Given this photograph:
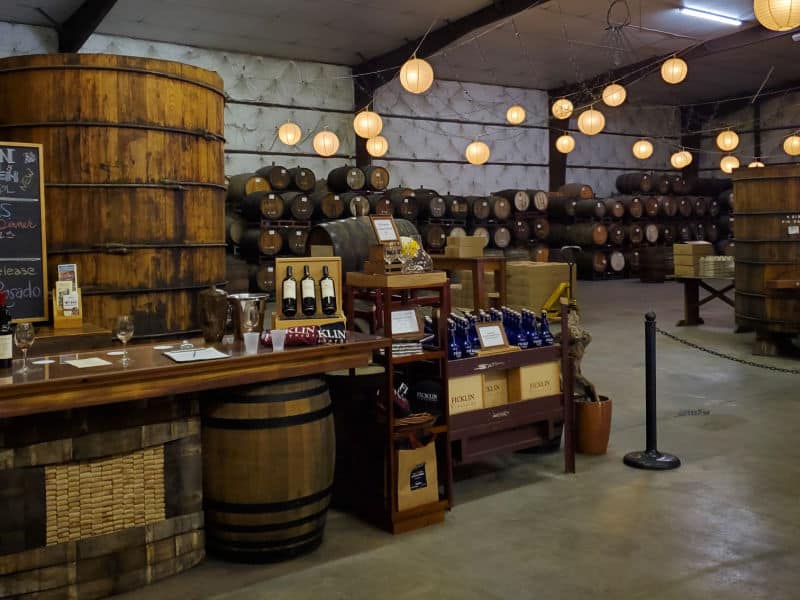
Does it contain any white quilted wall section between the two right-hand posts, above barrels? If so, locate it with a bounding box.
[565,103,681,197]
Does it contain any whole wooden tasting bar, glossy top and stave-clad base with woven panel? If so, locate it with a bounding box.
[0,333,389,600]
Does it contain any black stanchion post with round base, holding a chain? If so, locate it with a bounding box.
[623,311,681,471]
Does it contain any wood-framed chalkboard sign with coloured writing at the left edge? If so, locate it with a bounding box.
[0,142,48,322]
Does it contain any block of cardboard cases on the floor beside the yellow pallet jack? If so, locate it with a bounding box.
[506,261,577,312]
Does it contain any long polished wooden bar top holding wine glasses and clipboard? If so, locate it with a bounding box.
[0,332,390,418]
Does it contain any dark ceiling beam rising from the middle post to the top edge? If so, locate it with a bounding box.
[353,0,547,96]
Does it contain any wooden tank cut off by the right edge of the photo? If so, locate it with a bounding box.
[733,165,800,337]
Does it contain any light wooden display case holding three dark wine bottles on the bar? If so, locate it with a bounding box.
[272,256,345,329]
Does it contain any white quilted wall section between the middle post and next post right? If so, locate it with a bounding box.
[373,79,549,195]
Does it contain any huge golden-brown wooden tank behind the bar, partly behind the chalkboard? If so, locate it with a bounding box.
[0,54,225,336]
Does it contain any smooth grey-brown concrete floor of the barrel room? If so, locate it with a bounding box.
[120,281,800,600]
